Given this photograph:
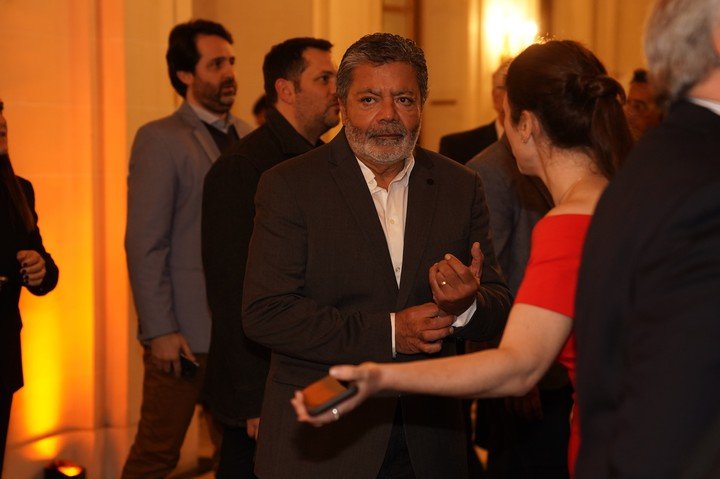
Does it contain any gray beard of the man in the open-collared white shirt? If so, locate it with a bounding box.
[345,120,420,165]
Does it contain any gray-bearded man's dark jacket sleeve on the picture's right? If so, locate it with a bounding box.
[455,174,512,341]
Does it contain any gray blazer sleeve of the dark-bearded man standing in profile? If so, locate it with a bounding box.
[125,126,179,340]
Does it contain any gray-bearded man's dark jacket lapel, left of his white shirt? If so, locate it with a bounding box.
[328,130,397,291]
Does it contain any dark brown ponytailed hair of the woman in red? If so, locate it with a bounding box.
[506,40,633,178]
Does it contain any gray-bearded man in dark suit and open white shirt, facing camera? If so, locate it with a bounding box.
[243,34,510,479]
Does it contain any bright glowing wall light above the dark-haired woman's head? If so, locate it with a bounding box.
[484,0,538,62]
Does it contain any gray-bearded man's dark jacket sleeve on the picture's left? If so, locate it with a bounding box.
[243,170,392,365]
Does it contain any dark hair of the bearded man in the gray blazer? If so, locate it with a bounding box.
[165,20,232,98]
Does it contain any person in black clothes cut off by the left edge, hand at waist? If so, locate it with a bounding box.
[0,98,58,476]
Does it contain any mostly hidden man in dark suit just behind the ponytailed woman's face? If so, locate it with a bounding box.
[438,60,510,164]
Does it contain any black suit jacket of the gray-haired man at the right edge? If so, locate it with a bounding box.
[575,101,720,479]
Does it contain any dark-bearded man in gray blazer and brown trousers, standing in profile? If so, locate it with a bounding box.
[122,20,250,479]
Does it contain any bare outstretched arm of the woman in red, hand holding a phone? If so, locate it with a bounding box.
[292,304,572,426]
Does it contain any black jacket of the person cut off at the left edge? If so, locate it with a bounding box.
[0,178,58,394]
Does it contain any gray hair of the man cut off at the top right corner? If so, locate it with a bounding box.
[645,0,720,101]
